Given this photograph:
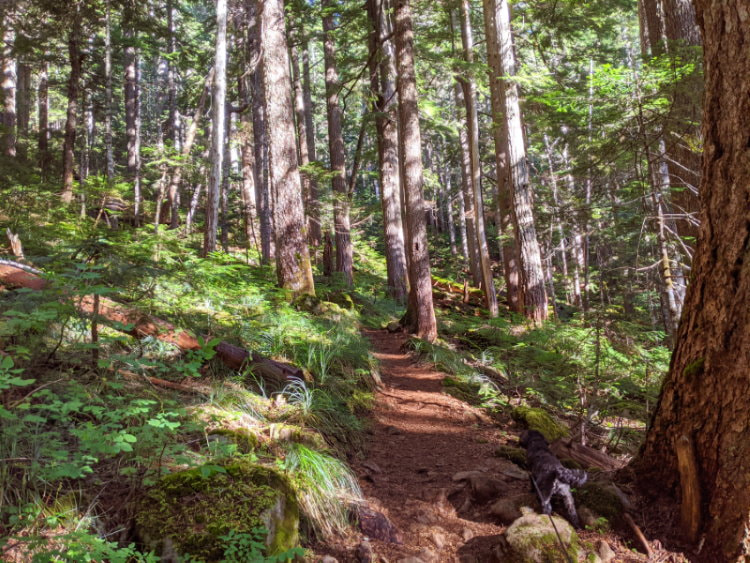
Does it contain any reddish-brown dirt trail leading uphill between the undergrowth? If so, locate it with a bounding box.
[315,331,656,563]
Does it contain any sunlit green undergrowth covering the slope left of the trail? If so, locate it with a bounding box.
[0,222,398,561]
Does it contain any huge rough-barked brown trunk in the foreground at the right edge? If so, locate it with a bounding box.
[636,4,750,561]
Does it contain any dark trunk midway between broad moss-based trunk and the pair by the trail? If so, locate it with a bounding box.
[322,0,354,286]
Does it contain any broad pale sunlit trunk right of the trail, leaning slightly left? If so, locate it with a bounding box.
[495,0,548,322]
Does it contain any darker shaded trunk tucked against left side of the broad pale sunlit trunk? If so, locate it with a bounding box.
[483,0,523,313]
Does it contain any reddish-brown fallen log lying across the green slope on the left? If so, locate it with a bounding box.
[0,261,305,386]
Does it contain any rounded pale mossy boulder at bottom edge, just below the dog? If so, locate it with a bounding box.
[505,511,582,563]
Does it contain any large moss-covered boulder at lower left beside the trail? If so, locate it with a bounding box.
[135,459,299,561]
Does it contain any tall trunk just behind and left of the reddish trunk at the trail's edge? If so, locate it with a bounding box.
[367,0,408,303]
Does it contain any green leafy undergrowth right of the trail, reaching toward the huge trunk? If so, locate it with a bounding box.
[410,304,670,457]
